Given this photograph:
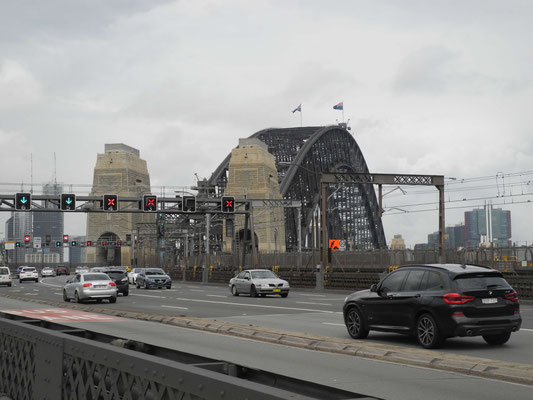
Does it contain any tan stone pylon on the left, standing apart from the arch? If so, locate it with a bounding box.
[86,143,157,266]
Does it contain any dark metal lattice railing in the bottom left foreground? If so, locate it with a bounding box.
[0,318,375,400]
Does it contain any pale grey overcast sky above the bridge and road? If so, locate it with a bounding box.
[0,0,533,246]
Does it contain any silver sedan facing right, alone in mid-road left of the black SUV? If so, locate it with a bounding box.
[229,269,290,297]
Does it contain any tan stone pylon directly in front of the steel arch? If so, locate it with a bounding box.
[224,139,285,252]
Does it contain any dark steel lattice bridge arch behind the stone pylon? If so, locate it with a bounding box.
[208,125,386,251]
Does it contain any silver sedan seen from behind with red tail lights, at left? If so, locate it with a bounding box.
[63,272,117,303]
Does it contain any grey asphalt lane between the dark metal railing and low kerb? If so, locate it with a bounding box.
[1,296,532,400]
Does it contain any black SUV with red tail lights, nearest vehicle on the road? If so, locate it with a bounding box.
[343,264,522,349]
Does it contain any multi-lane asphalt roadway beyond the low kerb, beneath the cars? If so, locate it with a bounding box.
[4,276,533,364]
